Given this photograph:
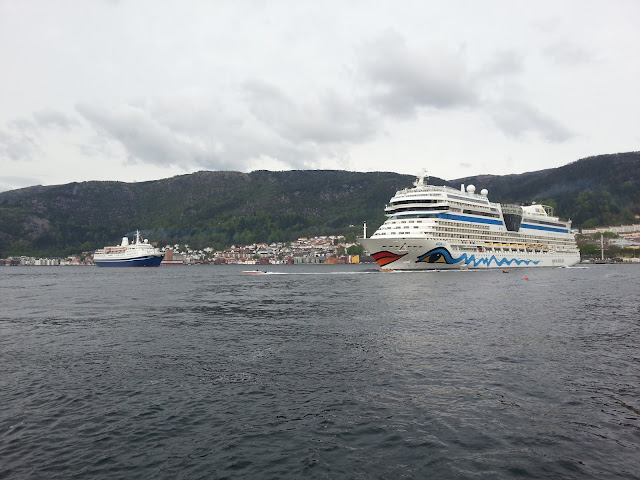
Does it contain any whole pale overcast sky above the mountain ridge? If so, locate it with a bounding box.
[0,0,640,191]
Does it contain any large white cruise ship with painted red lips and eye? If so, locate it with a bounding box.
[358,173,580,270]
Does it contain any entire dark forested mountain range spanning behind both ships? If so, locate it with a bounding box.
[0,152,640,258]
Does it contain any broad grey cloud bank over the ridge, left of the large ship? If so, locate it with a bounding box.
[76,80,377,171]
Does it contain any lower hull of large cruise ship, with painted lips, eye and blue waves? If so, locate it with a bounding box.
[358,238,580,270]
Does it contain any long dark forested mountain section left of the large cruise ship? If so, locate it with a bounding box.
[0,170,432,258]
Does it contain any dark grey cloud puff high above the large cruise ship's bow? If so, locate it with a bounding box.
[359,32,476,117]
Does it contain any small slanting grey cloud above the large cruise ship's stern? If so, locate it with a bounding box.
[489,100,574,143]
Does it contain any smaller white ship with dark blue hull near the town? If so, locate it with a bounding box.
[93,230,164,267]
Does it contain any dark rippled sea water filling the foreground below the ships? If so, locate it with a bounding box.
[0,265,640,479]
